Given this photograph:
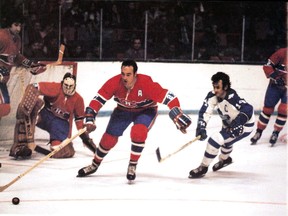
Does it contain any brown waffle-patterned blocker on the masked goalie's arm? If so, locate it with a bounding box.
[17,84,39,116]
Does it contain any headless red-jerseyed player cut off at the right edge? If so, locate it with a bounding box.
[251,48,288,146]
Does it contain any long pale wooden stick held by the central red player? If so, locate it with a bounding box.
[0,128,86,192]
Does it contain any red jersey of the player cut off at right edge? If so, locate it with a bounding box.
[263,48,288,84]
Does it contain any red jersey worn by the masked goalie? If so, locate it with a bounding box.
[38,82,85,135]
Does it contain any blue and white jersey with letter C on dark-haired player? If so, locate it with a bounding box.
[198,89,255,127]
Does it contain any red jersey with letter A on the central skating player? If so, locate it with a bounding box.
[89,74,180,112]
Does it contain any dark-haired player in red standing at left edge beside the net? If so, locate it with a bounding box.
[0,13,46,119]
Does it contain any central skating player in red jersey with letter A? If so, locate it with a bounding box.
[77,60,191,181]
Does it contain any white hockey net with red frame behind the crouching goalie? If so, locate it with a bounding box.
[0,62,77,149]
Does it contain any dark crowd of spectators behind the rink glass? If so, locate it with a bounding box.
[0,0,287,63]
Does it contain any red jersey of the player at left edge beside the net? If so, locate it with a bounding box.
[0,28,24,68]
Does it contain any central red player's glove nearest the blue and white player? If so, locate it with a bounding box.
[169,107,192,134]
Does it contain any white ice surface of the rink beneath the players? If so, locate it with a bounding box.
[0,115,287,216]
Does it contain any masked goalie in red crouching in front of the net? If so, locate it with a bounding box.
[9,72,96,159]
